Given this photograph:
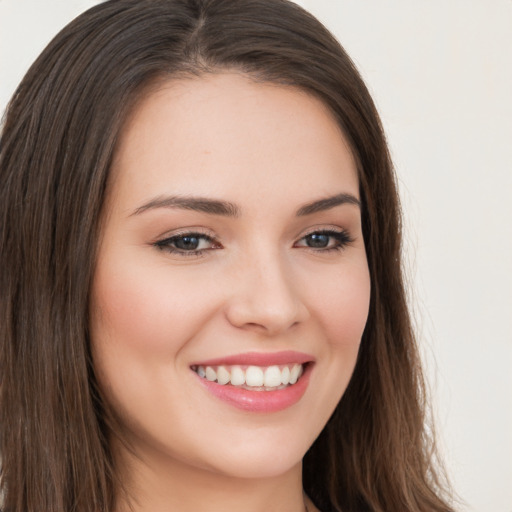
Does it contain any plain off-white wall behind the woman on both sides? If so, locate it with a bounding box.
[0,0,512,512]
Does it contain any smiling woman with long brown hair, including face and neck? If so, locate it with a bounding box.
[0,0,451,512]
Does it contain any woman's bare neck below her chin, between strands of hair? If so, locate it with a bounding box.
[116,440,306,512]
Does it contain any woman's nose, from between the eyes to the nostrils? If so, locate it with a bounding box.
[226,251,309,336]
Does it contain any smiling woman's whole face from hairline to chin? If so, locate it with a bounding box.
[91,73,370,477]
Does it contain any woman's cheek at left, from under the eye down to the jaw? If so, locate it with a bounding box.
[91,253,215,435]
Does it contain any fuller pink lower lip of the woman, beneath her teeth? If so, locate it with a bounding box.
[197,363,313,412]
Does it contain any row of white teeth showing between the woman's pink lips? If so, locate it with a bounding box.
[193,364,303,389]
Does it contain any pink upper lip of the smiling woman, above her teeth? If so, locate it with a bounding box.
[191,350,315,366]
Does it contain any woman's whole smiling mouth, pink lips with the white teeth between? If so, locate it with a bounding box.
[191,351,314,412]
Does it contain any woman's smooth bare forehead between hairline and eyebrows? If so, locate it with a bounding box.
[113,73,358,213]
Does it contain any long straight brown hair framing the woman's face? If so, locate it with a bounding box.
[0,0,451,512]
